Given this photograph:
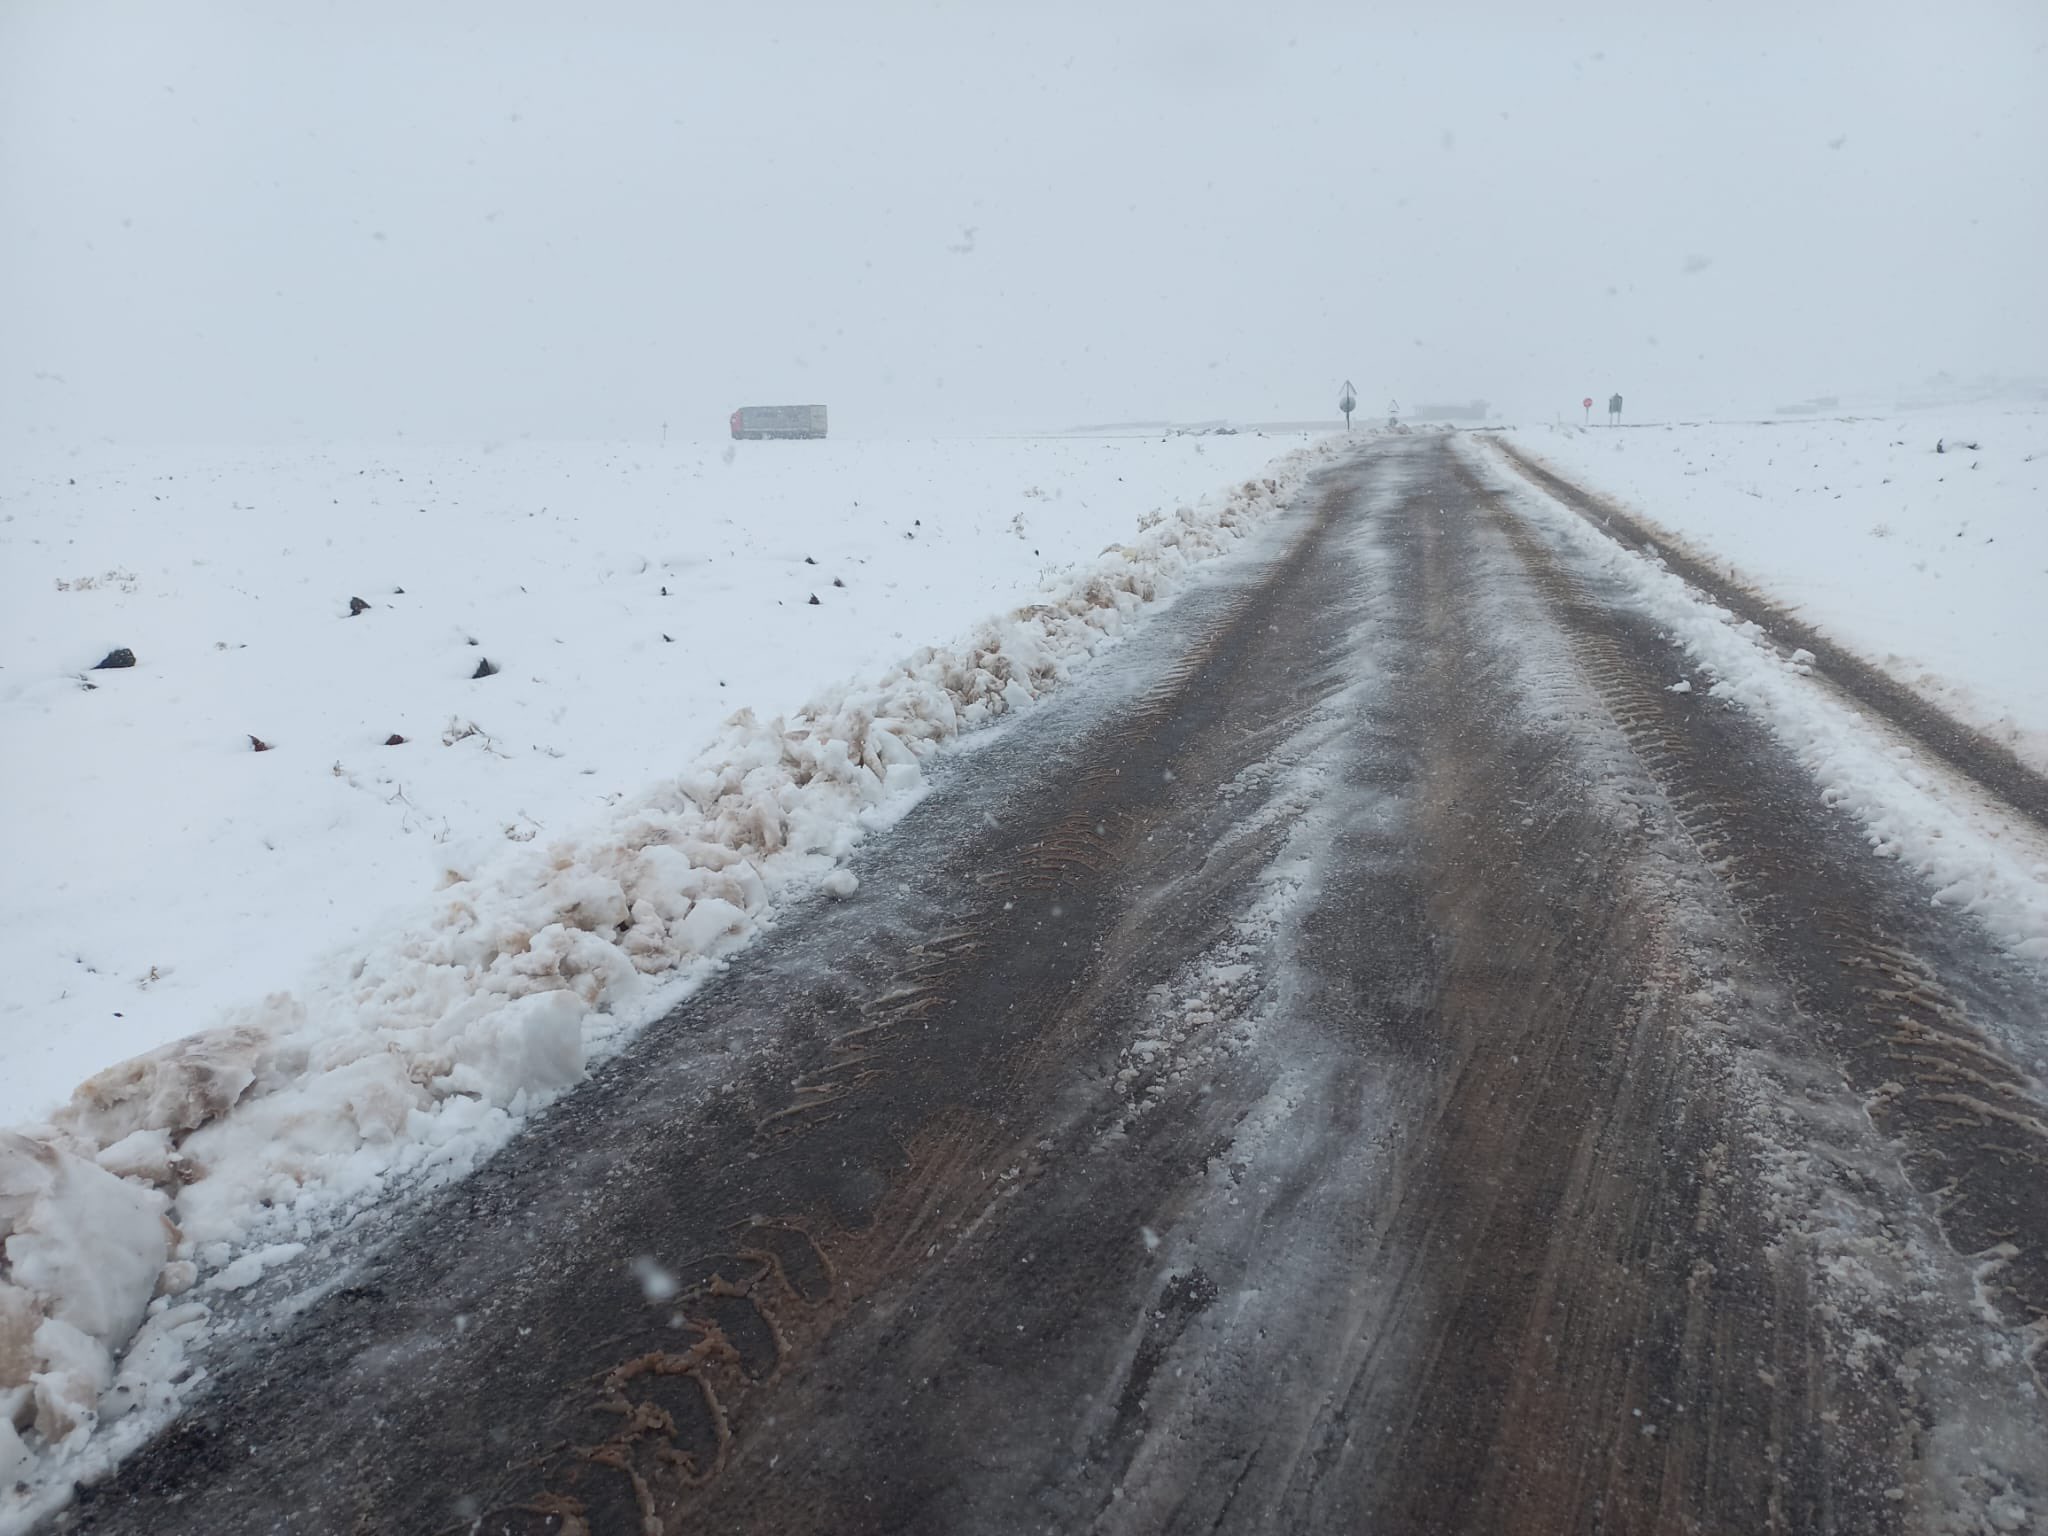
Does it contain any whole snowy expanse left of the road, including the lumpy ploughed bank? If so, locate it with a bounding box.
[0,436,1337,1530]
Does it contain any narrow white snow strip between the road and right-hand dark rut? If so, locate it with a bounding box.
[1468,428,2048,963]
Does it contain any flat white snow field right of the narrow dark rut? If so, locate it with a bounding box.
[1509,406,2048,770]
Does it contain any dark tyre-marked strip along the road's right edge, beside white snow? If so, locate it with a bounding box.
[1503,462,2048,1329]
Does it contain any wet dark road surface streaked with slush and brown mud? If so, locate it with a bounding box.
[59,436,2048,1536]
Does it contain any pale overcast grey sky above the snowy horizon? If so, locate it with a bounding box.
[0,0,2048,440]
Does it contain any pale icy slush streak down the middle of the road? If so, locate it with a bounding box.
[1075,483,1407,1526]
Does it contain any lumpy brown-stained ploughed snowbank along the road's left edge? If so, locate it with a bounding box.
[0,428,1341,1489]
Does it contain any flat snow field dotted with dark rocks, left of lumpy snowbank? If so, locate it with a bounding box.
[0,434,1305,1124]
